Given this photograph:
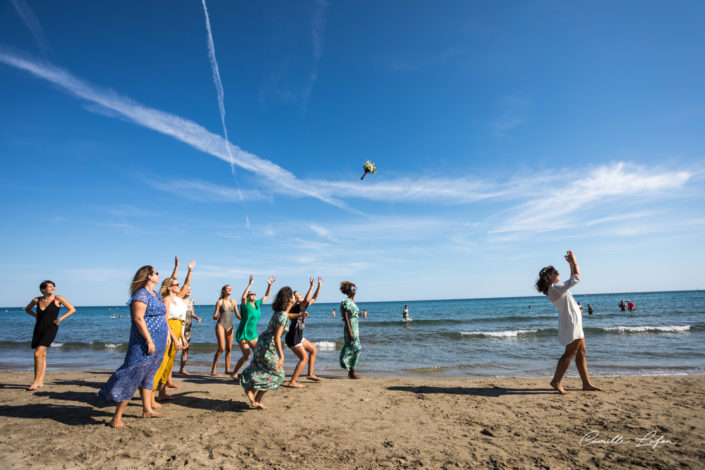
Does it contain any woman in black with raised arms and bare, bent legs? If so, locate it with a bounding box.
[285,277,323,388]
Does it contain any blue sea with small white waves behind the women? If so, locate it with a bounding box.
[0,291,705,377]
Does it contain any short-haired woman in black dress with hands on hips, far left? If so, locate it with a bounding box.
[24,281,76,391]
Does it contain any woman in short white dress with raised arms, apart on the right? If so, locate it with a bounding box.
[536,250,602,395]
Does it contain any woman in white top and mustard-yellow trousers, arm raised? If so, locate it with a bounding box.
[152,258,196,402]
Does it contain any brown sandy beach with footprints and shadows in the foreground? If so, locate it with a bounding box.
[0,371,705,468]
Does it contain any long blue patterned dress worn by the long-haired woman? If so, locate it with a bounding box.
[98,288,167,403]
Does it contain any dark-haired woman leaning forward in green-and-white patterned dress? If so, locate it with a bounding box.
[240,286,296,410]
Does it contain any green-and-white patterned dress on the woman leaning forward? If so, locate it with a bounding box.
[240,312,289,390]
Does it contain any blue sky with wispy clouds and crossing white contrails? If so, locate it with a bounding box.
[0,0,705,305]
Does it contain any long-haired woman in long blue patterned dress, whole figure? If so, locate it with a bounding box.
[98,266,169,429]
